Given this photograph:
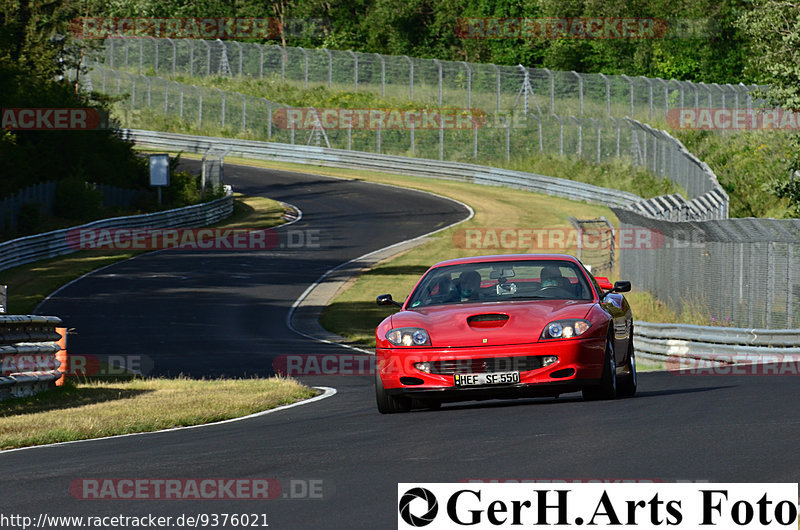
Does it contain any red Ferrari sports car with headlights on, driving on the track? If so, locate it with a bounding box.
[375,254,636,414]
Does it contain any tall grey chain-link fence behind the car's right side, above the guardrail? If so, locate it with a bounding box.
[613,208,800,328]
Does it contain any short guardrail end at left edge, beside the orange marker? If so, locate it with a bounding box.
[0,315,62,400]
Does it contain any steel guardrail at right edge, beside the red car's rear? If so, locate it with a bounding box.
[634,322,800,365]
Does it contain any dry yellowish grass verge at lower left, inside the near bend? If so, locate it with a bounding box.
[0,378,317,449]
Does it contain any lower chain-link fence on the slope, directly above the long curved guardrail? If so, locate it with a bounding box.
[82,66,727,219]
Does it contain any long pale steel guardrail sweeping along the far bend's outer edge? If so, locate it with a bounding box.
[120,129,642,207]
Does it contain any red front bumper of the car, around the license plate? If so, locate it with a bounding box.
[376,337,606,401]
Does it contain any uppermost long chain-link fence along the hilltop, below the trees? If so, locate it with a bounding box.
[97,37,763,122]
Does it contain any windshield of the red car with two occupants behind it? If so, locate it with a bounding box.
[408,260,592,308]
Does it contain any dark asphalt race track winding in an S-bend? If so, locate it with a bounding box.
[0,165,800,529]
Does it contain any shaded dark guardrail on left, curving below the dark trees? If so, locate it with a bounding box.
[0,188,233,270]
